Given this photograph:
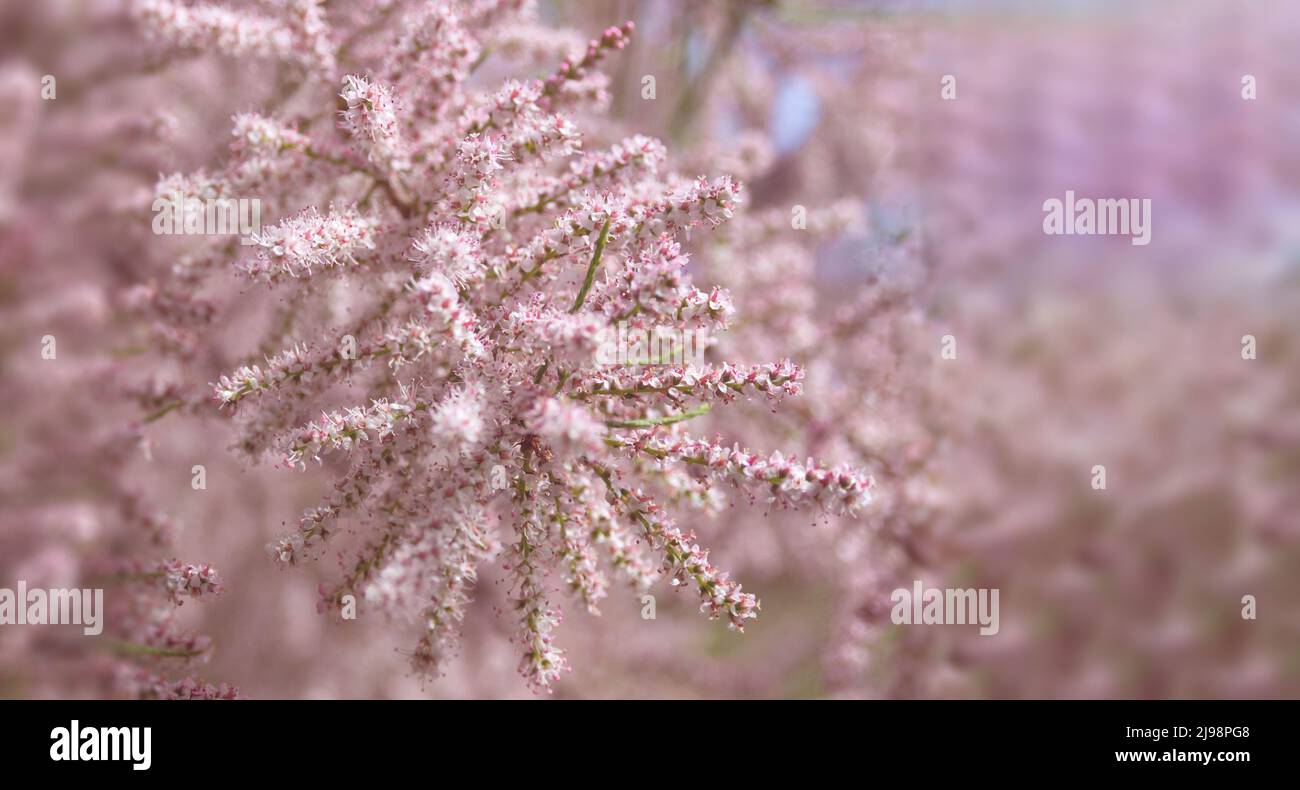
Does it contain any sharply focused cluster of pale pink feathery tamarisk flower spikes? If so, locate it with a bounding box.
[126,0,872,691]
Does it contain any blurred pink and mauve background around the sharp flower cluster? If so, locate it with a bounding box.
[0,0,1300,698]
